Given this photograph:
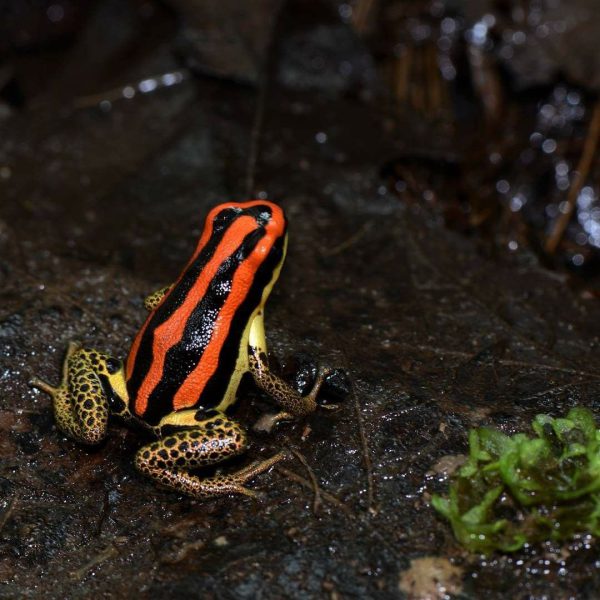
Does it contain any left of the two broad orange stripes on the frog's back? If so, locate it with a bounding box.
[135,216,256,415]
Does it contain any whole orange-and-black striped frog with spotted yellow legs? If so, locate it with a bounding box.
[32,200,330,498]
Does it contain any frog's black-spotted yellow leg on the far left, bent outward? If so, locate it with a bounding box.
[31,343,115,444]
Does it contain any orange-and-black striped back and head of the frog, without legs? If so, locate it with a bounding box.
[126,200,286,425]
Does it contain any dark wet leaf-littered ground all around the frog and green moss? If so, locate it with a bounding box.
[0,0,600,599]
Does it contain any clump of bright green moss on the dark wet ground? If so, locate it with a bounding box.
[431,408,600,553]
